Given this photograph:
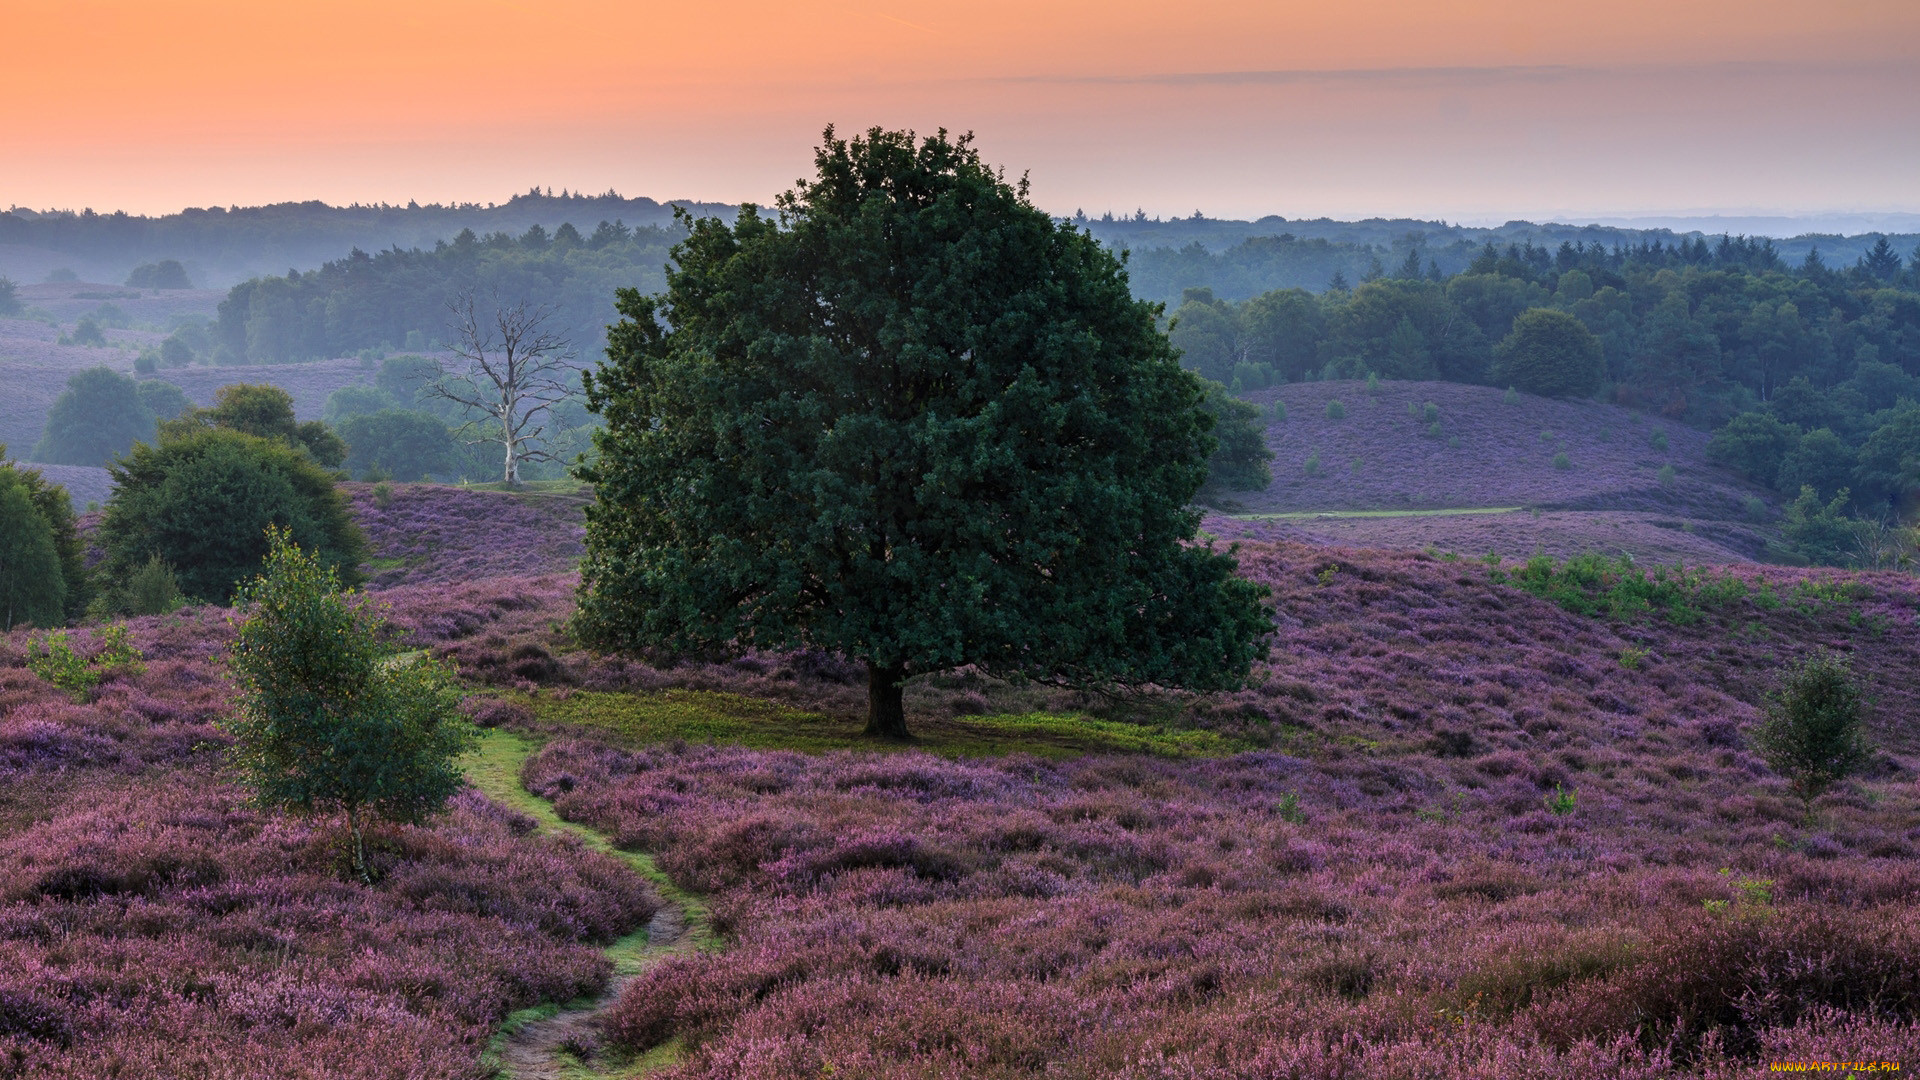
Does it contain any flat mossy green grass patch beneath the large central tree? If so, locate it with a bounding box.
[534,690,1248,757]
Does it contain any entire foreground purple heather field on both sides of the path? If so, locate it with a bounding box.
[0,426,1920,1080]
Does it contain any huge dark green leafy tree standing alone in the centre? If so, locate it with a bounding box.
[578,129,1269,736]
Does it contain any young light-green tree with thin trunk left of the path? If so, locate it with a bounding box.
[221,528,474,882]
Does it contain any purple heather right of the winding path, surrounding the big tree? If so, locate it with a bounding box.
[360,544,1920,1080]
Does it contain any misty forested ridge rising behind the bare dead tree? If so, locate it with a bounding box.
[213,221,684,363]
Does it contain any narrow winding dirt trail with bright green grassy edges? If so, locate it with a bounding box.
[467,728,714,1080]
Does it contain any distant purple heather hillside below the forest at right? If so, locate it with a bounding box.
[1210,380,1778,563]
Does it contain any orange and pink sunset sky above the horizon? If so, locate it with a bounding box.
[11,0,1920,221]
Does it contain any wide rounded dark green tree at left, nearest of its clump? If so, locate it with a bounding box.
[100,429,365,603]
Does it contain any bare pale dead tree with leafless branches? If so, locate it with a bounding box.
[424,292,580,484]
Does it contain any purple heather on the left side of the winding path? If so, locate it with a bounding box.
[0,595,659,1080]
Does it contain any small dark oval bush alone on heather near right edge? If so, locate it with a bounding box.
[1753,651,1868,809]
